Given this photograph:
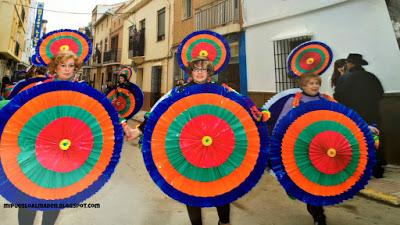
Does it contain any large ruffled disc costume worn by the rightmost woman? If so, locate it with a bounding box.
[270,100,375,206]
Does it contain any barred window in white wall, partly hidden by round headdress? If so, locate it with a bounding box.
[274,36,311,92]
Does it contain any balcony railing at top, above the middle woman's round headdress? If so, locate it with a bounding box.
[195,0,240,30]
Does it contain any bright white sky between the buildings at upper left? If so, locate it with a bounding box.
[38,0,124,32]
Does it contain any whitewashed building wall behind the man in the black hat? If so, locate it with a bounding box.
[244,0,400,93]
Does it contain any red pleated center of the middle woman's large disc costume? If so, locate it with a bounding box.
[179,115,235,168]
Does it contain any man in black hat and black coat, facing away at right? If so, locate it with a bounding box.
[333,53,384,178]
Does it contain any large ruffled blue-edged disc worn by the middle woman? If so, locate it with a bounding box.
[142,84,268,207]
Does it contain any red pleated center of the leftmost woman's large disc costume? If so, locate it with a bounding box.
[35,117,93,173]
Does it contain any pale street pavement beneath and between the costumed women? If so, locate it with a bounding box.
[0,118,400,225]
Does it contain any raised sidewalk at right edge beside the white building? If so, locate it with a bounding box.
[360,165,400,206]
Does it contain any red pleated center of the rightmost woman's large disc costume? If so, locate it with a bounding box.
[309,131,352,174]
